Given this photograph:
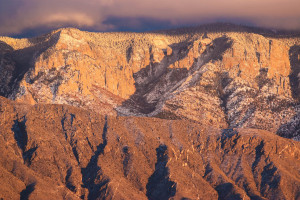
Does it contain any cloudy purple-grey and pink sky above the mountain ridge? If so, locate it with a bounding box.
[0,0,300,36]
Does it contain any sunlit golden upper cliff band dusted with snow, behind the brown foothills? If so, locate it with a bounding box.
[0,29,300,139]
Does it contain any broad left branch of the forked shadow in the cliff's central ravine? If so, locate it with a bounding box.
[118,38,192,114]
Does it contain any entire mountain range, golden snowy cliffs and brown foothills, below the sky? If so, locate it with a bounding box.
[0,24,300,200]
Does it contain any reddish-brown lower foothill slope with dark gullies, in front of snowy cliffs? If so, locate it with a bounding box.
[0,98,300,200]
